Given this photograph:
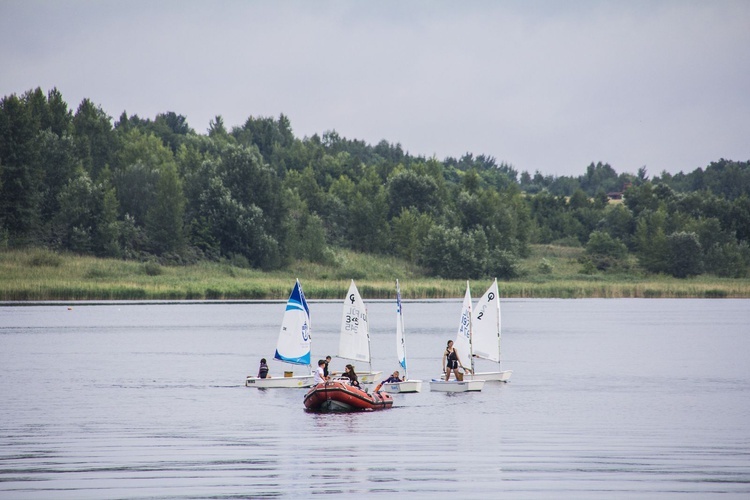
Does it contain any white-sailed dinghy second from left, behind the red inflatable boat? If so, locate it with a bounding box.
[338,280,383,384]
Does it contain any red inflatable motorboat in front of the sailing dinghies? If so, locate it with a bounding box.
[305,378,393,412]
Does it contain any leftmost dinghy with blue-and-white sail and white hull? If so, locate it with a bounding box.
[245,280,313,389]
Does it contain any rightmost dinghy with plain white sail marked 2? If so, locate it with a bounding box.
[471,278,513,382]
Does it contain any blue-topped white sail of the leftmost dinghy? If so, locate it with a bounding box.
[274,280,311,365]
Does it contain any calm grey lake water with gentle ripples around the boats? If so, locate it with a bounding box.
[0,299,750,500]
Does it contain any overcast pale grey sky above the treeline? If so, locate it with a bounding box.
[0,0,750,175]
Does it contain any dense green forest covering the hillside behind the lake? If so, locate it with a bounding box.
[0,88,750,279]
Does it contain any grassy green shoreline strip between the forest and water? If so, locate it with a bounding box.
[0,245,750,302]
